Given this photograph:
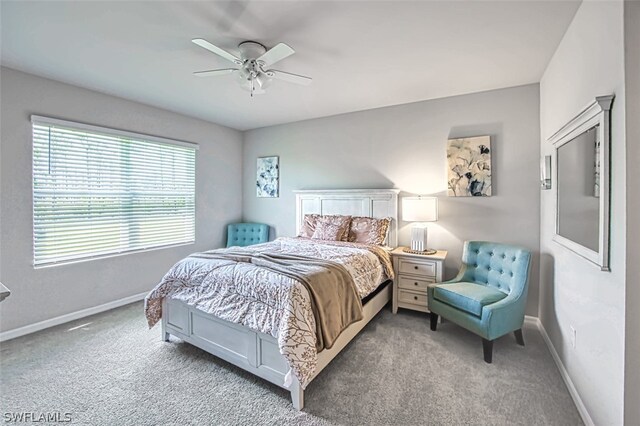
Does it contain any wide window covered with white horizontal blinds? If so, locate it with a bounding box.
[31,116,197,266]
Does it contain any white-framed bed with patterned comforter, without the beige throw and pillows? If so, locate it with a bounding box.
[145,190,398,410]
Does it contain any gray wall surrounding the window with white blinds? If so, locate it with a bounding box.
[0,68,242,331]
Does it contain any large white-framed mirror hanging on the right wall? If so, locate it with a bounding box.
[549,96,613,271]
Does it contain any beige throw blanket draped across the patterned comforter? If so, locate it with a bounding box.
[191,249,362,352]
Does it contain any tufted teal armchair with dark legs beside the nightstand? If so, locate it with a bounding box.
[427,241,531,363]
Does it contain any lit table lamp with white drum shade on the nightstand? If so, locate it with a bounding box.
[402,197,438,255]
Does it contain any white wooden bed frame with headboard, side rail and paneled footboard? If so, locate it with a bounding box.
[162,189,398,410]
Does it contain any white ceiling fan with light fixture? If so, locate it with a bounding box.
[191,38,312,97]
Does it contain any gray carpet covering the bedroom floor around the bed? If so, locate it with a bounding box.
[0,303,582,425]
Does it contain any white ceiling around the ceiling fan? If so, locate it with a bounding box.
[1,0,579,130]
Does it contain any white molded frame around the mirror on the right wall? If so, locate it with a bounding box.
[548,95,613,271]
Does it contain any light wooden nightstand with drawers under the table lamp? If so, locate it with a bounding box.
[391,247,447,314]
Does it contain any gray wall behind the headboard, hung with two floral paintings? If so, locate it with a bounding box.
[243,84,540,316]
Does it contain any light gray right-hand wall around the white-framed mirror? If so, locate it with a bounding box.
[539,0,624,425]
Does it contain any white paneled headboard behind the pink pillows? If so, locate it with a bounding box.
[293,189,400,247]
